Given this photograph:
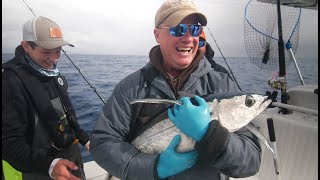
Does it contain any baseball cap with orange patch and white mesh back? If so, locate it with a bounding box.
[23,16,74,49]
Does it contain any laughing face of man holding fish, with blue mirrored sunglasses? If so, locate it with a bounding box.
[154,14,202,77]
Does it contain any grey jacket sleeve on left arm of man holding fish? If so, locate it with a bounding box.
[90,82,157,180]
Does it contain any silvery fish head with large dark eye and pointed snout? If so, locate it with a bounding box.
[209,94,272,132]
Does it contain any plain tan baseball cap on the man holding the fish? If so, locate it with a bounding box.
[155,0,207,27]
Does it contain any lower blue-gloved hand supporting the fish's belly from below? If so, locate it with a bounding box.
[157,135,199,179]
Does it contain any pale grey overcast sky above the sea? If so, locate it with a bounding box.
[2,0,318,58]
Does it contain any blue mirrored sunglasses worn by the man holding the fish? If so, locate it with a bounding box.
[159,24,203,37]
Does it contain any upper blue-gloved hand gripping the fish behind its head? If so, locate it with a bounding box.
[168,96,210,141]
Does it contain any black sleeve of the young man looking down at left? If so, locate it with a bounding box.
[2,70,54,174]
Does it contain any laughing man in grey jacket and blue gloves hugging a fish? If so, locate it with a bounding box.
[90,0,261,180]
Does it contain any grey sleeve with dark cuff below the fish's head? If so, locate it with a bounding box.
[195,121,261,178]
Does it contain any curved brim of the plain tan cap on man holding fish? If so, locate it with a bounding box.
[164,10,207,26]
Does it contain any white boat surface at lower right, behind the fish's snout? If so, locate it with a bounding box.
[231,85,318,180]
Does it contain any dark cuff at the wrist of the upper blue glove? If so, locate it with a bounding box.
[195,120,229,162]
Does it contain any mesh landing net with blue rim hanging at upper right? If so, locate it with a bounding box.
[244,0,301,70]
